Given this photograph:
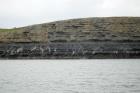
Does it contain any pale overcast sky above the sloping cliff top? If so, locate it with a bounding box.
[0,0,140,28]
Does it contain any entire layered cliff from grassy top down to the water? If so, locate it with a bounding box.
[0,17,140,59]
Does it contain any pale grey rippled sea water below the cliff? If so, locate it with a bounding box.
[0,60,140,93]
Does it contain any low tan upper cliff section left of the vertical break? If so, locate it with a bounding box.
[0,26,48,43]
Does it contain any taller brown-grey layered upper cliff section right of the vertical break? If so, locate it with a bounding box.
[44,18,140,42]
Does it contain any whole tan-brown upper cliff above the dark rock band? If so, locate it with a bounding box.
[0,17,140,42]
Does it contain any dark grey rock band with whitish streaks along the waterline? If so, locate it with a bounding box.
[0,41,140,59]
